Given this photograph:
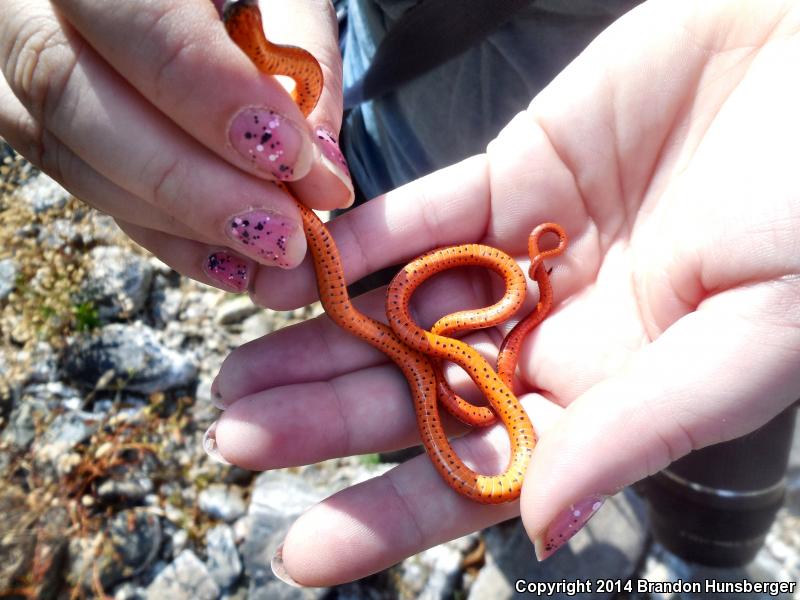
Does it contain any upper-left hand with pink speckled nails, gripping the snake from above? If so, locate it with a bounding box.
[0,0,353,292]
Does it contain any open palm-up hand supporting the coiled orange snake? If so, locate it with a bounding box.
[211,0,800,585]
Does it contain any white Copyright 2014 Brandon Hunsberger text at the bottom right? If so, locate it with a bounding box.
[514,579,798,597]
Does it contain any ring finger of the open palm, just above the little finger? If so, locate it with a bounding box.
[215,365,438,471]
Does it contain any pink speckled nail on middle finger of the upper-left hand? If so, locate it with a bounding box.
[228,210,304,268]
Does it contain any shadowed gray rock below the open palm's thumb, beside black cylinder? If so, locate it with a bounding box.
[468,490,647,600]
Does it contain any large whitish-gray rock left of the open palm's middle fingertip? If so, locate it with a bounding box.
[64,323,197,394]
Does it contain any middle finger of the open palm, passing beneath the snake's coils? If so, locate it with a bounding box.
[214,260,502,406]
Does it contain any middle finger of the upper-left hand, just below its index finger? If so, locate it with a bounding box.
[0,0,305,267]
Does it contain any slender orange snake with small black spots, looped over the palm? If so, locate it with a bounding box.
[224,0,567,504]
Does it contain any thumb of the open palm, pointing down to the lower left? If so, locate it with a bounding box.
[520,281,800,560]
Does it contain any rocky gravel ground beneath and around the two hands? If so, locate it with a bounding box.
[0,144,800,600]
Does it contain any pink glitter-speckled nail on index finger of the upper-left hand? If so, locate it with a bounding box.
[228,107,314,181]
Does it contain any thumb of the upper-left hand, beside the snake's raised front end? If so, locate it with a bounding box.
[259,0,353,210]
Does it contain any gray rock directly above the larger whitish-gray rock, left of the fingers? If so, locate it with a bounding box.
[87,246,153,321]
